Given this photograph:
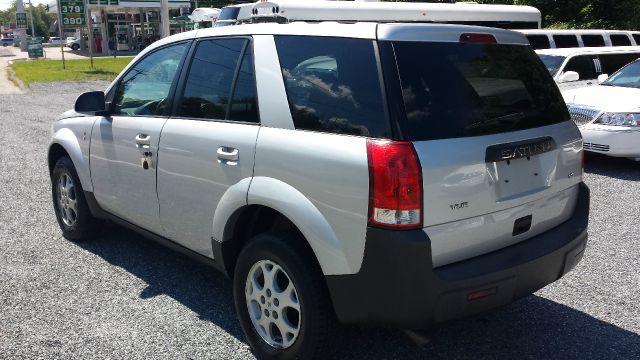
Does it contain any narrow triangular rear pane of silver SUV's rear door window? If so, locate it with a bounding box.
[228,46,260,123]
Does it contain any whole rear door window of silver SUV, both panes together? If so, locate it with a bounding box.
[178,39,258,122]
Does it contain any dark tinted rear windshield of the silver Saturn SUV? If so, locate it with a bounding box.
[393,42,569,141]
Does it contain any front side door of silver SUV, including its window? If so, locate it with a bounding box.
[90,42,189,232]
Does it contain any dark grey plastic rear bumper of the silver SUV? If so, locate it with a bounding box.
[326,183,589,328]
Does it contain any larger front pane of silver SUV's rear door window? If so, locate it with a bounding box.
[177,39,247,120]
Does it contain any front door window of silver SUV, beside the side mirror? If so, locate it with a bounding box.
[113,43,189,116]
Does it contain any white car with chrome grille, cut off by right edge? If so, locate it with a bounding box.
[562,59,640,161]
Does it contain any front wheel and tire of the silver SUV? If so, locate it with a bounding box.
[51,156,100,241]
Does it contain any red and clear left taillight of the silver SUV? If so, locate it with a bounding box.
[367,140,422,229]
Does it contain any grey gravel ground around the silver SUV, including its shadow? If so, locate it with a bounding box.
[0,82,640,359]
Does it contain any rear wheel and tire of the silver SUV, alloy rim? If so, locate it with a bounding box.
[233,233,336,359]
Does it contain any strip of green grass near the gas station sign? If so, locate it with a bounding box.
[13,57,132,86]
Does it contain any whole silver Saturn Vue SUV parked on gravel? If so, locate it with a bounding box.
[48,23,589,358]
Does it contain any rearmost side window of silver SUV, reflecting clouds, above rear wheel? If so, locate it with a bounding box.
[275,36,391,138]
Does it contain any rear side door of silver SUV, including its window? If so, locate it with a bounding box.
[158,38,260,256]
